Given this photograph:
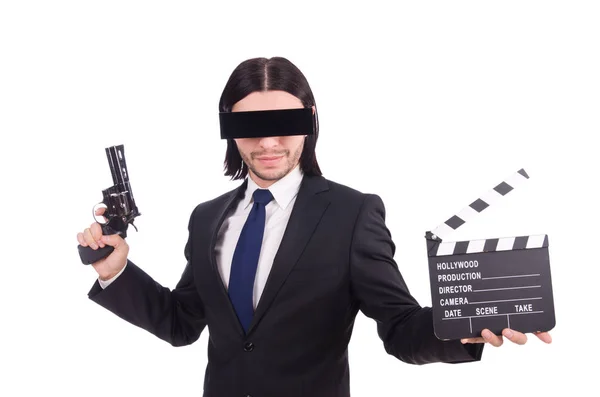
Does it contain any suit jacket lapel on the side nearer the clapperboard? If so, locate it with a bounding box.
[246,176,329,333]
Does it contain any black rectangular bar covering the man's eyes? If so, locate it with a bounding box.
[219,108,316,139]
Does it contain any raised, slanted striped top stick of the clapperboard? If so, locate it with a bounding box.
[431,169,529,240]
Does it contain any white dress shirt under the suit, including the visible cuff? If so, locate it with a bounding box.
[98,165,303,309]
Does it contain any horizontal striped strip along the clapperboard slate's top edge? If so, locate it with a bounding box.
[428,234,548,257]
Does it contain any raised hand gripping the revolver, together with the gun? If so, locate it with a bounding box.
[77,145,141,277]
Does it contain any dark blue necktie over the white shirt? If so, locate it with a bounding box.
[229,189,273,332]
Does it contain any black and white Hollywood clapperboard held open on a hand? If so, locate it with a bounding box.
[425,169,555,340]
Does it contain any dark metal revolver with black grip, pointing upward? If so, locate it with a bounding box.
[77,145,141,265]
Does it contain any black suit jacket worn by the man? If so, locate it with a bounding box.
[89,176,483,397]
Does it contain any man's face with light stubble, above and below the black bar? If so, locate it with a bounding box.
[231,91,314,188]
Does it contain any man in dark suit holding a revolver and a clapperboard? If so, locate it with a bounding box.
[77,58,550,397]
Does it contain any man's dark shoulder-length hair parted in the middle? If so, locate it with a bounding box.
[219,57,321,180]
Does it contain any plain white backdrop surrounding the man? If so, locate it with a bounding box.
[0,0,600,397]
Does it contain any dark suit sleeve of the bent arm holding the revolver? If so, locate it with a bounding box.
[88,209,206,346]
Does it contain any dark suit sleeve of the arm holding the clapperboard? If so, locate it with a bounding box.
[350,194,483,364]
